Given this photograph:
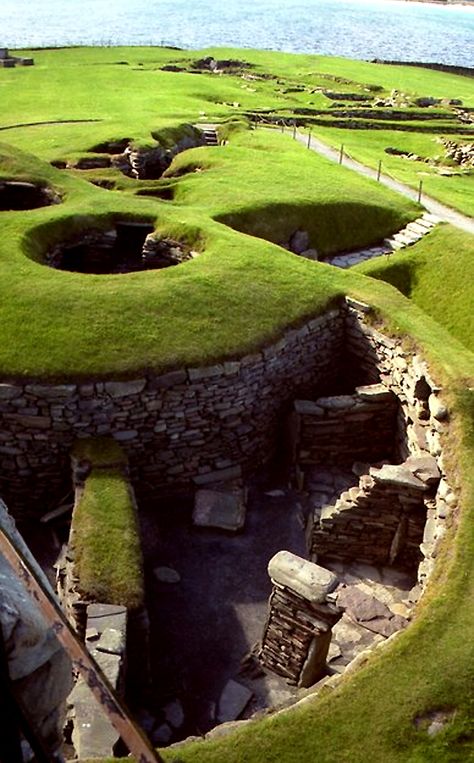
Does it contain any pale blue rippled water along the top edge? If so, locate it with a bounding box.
[0,0,474,66]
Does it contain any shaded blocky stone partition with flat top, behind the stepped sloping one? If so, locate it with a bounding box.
[294,384,397,466]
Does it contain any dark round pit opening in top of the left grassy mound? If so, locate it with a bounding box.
[46,221,193,275]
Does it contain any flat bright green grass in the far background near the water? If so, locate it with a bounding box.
[0,48,474,215]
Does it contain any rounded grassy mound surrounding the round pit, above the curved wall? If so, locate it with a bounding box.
[0,133,417,378]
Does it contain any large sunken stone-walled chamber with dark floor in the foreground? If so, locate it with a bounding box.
[0,300,453,757]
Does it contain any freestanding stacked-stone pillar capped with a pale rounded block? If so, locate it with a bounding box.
[259,551,343,687]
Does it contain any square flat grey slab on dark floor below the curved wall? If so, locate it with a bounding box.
[193,489,246,532]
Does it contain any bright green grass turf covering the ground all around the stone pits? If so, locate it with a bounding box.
[0,44,474,763]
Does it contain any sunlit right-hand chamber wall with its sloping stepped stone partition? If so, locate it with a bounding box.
[308,299,456,584]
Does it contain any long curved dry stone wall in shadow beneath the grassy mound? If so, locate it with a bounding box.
[0,310,344,513]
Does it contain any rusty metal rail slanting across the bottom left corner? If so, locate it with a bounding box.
[0,528,163,763]
